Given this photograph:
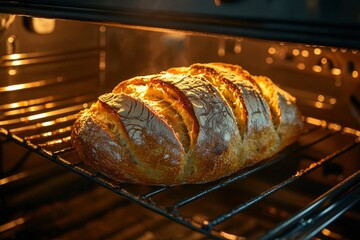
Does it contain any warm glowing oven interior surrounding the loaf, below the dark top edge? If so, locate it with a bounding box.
[0,15,360,239]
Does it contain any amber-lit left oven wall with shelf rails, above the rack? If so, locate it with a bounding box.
[0,16,100,106]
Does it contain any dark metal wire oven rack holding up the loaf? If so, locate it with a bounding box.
[0,96,360,239]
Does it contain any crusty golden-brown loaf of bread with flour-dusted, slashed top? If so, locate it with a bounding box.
[72,63,303,185]
